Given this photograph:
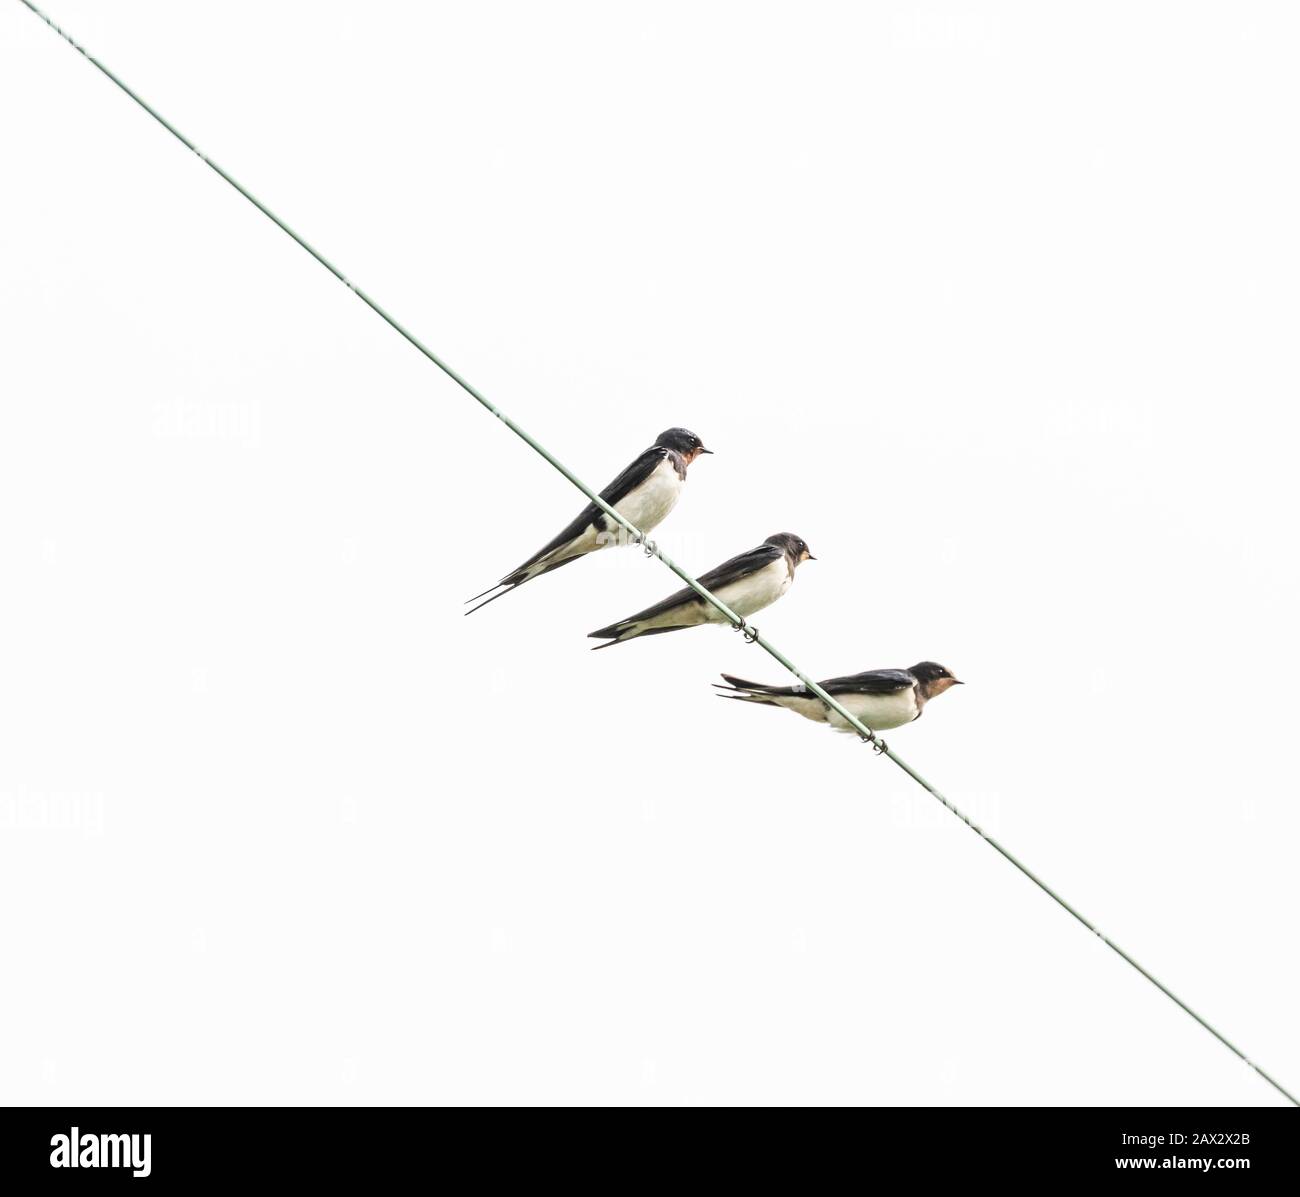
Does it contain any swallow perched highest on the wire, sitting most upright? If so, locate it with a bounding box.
[465,428,712,615]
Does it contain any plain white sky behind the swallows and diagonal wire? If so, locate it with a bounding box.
[0,0,1300,1105]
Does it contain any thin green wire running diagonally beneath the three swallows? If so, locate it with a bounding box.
[20,0,1300,1106]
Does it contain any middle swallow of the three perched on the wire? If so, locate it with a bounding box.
[588,532,816,651]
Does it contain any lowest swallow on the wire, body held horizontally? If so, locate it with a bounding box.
[714,660,963,734]
